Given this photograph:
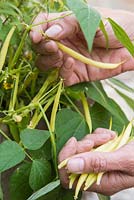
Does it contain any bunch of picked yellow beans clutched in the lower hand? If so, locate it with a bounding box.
[58,121,133,199]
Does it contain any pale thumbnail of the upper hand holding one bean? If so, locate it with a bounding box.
[45,25,62,38]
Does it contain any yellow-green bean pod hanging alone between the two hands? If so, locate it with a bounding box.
[81,92,92,133]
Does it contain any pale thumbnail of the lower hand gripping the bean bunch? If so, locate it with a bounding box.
[67,158,84,174]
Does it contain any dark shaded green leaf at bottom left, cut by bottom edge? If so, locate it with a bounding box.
[9,163,32,200]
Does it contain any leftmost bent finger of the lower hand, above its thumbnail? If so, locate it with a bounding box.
[58,137,77,162]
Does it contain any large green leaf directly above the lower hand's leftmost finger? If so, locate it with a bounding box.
[55,109,89,152]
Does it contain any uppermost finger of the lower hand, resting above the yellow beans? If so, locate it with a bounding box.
[82,128,116,147]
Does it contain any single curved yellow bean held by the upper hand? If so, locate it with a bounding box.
[56,41,126,69]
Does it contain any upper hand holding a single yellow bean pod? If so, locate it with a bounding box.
[30,8,134,85]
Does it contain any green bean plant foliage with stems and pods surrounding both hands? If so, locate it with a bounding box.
[0,0,134,200]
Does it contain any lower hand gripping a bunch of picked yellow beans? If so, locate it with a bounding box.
[59,129,134,196]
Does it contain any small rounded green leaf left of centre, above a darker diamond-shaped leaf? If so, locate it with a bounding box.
[20,128,50,150]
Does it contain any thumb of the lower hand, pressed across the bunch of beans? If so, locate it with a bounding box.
[67,145,131,174]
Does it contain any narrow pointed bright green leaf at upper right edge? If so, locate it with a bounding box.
[108,18,134,56]
